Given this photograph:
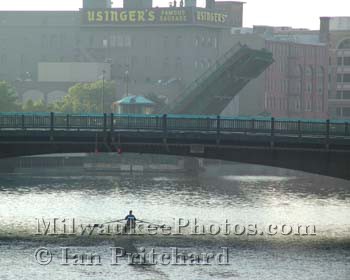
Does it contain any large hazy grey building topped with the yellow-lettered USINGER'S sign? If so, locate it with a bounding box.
[0,0,244,107]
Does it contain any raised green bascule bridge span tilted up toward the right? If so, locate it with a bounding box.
[162,44,274,115]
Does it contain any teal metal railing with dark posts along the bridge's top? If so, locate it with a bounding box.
[0,113,350,137]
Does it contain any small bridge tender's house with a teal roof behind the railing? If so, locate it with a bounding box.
[113,95,155,114]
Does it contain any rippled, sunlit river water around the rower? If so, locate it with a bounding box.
[0,165,350,280]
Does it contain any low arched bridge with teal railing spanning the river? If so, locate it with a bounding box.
[0,113,350,179]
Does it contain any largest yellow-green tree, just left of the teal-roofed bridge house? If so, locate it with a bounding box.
[53,81,115,113]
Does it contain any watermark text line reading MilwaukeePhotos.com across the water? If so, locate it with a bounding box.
[35,218,316,236]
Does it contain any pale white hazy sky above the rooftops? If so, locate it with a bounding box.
[0,0,350,29]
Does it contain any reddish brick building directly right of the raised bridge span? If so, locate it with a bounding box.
[224,26,328,118]
